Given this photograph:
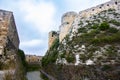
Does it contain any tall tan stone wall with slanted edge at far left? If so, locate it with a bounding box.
[0,10,19,69]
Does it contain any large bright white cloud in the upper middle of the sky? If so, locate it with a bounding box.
[19,0,56,33]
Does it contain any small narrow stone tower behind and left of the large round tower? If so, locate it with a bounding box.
[48,31,58,49]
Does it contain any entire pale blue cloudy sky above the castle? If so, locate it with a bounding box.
[0,0,110,56]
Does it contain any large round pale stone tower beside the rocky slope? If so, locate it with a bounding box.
[59,12,77,42]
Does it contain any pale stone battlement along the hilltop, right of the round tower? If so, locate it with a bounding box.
[79,0,120,18]
